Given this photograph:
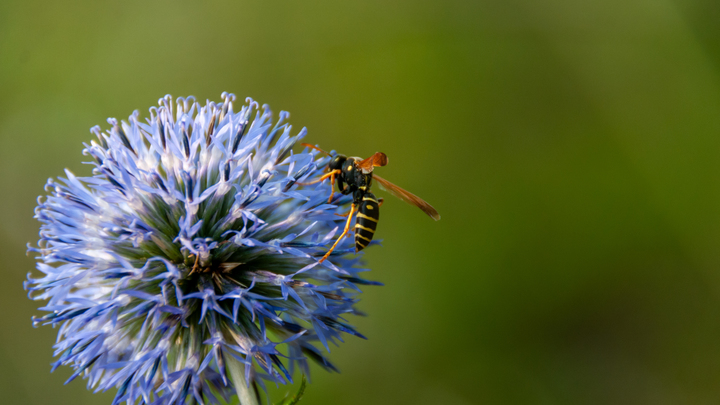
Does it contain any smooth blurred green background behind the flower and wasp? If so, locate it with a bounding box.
[0,0,720,405]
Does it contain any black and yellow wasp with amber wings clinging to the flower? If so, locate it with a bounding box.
[298,143,440,263]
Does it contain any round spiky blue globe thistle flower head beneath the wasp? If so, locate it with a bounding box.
[25,93,379,404]
